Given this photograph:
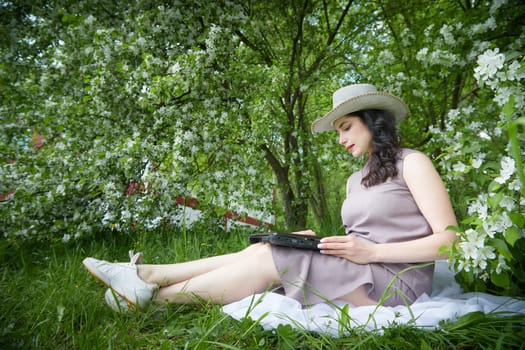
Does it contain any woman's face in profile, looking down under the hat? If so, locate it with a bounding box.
[334,115,373,158]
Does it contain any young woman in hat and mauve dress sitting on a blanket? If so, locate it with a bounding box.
[83,84,457,310]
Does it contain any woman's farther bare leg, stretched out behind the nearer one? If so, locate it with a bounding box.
[137,243,264,287]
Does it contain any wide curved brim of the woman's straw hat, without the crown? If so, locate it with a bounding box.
[312,91,408,133]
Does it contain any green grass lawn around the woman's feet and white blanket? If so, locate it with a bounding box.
[0,227,525,350]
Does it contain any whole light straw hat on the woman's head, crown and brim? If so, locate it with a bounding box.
[312,84,408,133]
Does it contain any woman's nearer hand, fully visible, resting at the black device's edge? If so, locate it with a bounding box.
[318,235,375,264]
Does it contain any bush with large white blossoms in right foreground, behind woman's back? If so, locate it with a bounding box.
[432,48,525,294]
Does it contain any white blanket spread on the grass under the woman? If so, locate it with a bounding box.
[223,261,525,337]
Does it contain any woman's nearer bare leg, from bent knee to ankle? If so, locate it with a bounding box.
[150,244,279,304]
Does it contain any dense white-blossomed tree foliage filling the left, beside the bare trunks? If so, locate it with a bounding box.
[0,2,272,240]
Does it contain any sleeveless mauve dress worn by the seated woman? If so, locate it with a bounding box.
[272,149,434,306]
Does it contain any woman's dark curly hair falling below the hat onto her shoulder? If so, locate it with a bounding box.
[351,109,401,187]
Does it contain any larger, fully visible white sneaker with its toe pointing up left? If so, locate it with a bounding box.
[82,253,159,308]
